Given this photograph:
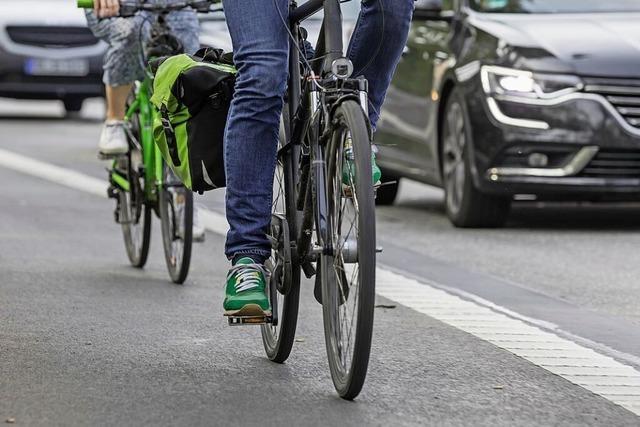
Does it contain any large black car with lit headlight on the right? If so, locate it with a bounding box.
[377,0,640,227]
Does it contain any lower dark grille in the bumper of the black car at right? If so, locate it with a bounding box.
[579,149,640,178]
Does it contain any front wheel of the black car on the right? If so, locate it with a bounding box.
[441,89,511,227]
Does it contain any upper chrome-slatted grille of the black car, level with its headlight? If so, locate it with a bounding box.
[584,78,640,129]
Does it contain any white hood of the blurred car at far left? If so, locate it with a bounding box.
[0,0,87,27]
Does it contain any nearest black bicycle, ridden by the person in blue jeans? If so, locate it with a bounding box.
[250,0,377,399]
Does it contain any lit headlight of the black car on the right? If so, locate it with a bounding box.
[480,65,583,99]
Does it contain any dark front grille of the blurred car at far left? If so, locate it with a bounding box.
[7,26,98,48]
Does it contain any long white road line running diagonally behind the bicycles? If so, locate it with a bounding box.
[0,149,640,415]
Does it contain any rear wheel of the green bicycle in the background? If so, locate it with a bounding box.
[119,98,151,268]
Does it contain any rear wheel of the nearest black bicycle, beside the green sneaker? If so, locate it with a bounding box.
[262,106,300,363]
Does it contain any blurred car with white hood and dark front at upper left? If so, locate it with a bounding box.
[0,0,106,112]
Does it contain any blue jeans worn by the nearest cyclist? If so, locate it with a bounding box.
[224,0,414,262]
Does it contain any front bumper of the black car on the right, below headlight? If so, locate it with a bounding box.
[466,79,640,200]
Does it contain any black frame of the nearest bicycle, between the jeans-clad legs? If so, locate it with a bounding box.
[284,0,344,277]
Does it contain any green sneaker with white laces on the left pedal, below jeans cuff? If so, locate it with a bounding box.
[223,257,271,316]
